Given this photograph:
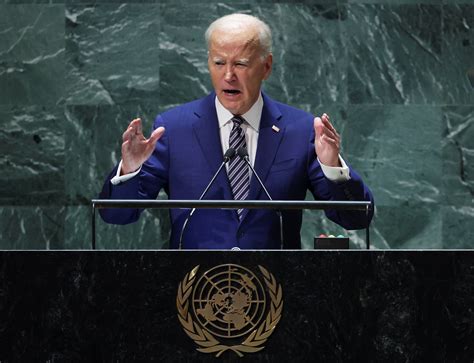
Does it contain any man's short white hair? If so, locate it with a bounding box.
[204,13,272,58]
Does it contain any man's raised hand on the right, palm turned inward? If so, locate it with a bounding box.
[314,113,341,166]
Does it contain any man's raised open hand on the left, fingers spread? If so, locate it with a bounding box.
[120,118,165,175]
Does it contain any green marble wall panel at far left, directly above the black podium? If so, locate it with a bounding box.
[0,206,65,250]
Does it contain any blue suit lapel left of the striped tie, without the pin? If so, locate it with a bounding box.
[193,93,232,199]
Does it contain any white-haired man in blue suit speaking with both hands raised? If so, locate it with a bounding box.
[100,14,373,249]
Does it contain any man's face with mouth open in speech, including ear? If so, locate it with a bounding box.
[208,30,272,115]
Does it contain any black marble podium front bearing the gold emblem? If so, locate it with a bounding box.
[0,250,474,362]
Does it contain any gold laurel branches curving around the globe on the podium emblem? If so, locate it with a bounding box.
[176,265,283,357]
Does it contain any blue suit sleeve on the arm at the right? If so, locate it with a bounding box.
[308,125,374,229]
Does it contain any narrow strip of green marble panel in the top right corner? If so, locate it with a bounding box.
[439,5,474,105]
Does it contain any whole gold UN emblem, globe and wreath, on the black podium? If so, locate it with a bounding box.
[176,264,283,357]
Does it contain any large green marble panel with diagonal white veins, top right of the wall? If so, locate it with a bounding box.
[342,4,444,104]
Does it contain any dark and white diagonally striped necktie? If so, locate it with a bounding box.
[228,116,250,219]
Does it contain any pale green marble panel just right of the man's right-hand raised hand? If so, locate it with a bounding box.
[341,105,442,206]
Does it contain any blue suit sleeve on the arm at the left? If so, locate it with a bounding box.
[99,116,169,224]
